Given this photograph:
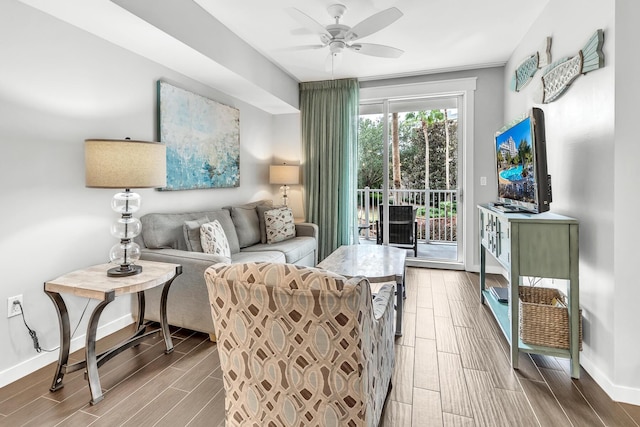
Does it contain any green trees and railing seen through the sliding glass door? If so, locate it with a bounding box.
[358,110,460,241]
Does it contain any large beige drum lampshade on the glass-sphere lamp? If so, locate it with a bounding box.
[84,139,167,188]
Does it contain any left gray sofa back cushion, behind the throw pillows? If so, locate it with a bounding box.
[140,209,240,254]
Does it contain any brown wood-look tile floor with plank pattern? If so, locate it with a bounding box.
[0,268,640,427]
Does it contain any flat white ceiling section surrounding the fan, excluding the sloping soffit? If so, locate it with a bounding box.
[194,0,549,81]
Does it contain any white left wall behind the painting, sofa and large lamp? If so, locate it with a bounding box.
[0,0,295,386]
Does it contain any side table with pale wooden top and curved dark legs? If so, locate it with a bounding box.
[44,261,182,405]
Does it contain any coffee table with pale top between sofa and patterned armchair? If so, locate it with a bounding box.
[318,245,407,336]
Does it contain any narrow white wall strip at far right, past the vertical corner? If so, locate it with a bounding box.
[611,0,640,404]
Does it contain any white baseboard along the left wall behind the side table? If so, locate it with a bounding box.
[0,314,133,387]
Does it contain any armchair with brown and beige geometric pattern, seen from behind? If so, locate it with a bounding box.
[205,263,394,427]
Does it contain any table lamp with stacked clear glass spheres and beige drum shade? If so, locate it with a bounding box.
[84,139,167,277]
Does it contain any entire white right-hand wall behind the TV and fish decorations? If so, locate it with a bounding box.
[504,0,640,404]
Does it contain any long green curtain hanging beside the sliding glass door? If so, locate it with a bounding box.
[300,79,359,260]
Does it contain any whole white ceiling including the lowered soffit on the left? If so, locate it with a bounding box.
[19,0,549,114]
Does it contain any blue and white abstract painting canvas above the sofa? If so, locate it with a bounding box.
[158,81,240,190]
